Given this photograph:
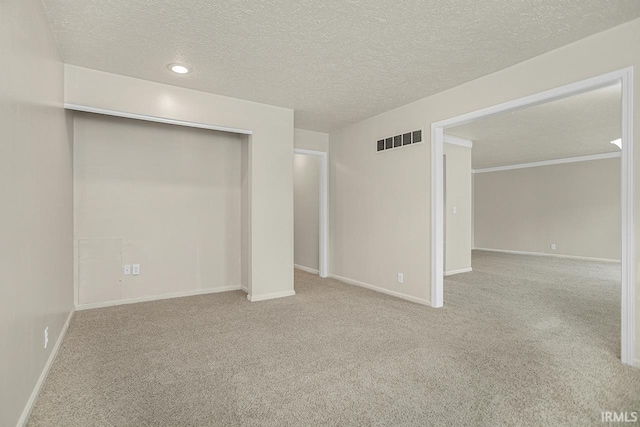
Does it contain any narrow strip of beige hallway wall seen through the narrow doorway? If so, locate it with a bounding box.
[293,154,320,270]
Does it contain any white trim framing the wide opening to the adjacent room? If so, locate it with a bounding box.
[431,67,635,365]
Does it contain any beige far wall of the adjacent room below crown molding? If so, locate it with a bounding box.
[474,158,622,260]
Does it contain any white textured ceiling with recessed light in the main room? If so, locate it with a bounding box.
[43,0,640,132]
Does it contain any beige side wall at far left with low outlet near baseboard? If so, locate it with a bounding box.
[0,0,73,426]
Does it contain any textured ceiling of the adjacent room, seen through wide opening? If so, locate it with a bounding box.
[446,85,622,169]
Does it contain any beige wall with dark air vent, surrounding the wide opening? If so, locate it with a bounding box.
[329,19,640,364]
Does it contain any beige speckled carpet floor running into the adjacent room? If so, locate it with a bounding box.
[29,251,640,427]
